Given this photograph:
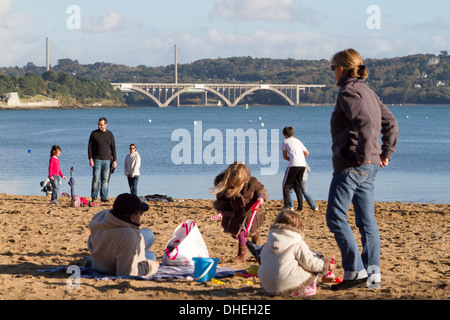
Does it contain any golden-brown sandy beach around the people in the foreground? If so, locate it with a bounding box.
[0,194,450,301]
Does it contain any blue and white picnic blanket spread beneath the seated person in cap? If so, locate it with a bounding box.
[38,265,243,280]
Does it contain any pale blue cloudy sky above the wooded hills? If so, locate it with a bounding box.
[0,0,450,67]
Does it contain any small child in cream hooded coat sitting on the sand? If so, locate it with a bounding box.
[258,209,334,297]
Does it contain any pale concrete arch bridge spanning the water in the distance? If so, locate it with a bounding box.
[111,83,325,107]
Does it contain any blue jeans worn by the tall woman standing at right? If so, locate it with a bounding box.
[326,164,381,286]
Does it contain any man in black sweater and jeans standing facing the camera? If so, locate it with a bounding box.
[88,117,117,202]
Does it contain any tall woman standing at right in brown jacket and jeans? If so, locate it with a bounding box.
[326,49,398,290]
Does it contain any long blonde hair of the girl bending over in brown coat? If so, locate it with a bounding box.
[212,162,251,198]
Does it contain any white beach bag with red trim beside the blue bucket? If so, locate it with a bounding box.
[162,220,209,266]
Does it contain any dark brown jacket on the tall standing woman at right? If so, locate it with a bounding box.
[330,75,398,174]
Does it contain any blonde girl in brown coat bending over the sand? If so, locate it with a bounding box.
[211,162,269,262]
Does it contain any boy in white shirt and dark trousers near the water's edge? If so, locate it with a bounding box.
[281,127,309,211]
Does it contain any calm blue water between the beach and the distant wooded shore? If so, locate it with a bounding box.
[0,106,450,203]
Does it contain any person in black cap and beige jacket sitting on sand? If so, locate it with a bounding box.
[88,193,159,276]
